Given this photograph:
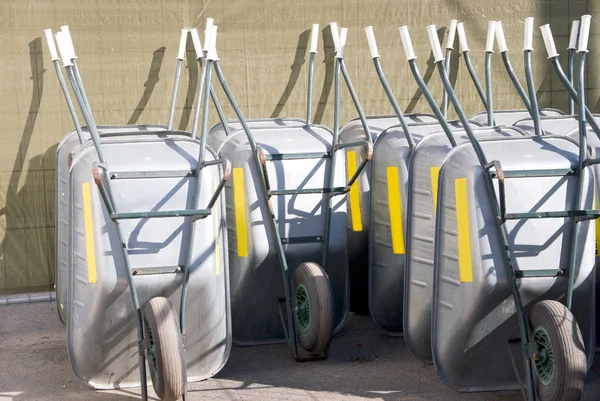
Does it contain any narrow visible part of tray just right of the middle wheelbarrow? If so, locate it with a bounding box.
[340,113,437,313]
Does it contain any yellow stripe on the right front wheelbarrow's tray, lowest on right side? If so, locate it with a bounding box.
[454,178,473,283]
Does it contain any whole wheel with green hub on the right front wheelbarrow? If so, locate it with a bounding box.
[529,300,587,401]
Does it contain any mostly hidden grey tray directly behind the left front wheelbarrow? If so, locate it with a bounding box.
[54,124,167,323]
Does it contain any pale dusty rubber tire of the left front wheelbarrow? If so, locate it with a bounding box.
[144,297,186,401]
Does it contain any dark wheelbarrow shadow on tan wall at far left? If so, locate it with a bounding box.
[0,37,56,293]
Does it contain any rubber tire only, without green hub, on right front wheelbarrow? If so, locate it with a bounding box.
[529,300,587,401]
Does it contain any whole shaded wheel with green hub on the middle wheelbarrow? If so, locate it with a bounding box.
[292,262,334,354]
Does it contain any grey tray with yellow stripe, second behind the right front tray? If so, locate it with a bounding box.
[366,121,481,333]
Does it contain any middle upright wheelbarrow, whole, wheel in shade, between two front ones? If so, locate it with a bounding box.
[202,25,372,360]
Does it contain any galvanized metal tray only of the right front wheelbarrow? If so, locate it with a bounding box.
[432,136,595,392]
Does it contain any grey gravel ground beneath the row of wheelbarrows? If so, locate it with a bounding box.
[0,304,600,401]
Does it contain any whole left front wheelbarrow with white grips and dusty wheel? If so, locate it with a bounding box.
[47,22,231,400]
